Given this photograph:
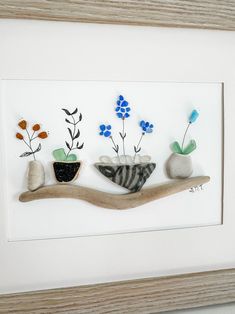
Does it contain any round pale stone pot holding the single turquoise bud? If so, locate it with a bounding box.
[166,153,193,179]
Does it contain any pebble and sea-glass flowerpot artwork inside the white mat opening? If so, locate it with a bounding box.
[1,80,223,241]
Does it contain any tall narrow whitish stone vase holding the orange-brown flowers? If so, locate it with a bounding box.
[28,160,45,191]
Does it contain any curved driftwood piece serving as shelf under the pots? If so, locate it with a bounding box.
[19,176,210,209]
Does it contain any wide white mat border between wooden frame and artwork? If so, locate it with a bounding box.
[0,20,235,293]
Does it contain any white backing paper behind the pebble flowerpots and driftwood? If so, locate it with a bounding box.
[1,80,222,240]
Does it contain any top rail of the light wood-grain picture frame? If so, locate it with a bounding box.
[0,0,235,30]
